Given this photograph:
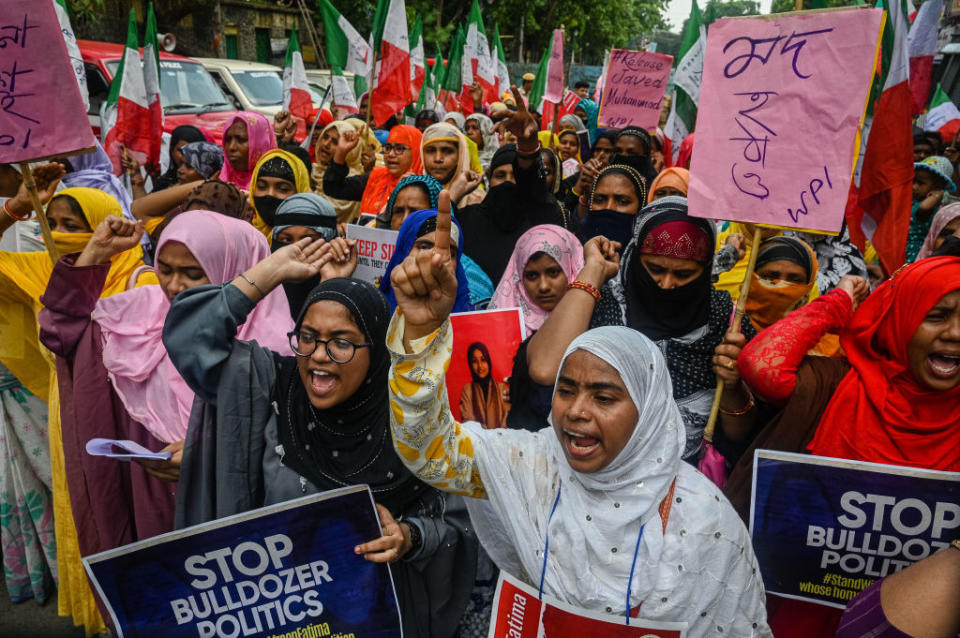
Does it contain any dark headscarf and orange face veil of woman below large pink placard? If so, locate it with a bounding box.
[746,237,819,331]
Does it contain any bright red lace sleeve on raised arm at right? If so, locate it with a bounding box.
[737,290,853,406]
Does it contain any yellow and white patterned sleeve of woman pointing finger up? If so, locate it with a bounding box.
[387,311,486,498]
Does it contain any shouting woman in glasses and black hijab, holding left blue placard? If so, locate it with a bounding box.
[163,238,488,638]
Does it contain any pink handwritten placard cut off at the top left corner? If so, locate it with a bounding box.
[0,0,94,163]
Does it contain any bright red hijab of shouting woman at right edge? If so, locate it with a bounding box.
[809,257,960,472]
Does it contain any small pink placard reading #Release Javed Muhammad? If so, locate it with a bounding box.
[598,49,673,131]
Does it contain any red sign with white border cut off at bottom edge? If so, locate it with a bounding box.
[487,571,687,638]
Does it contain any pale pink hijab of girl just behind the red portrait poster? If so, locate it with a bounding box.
[488,224,583,338]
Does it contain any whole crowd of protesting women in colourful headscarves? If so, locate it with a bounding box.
[0,84,960,638]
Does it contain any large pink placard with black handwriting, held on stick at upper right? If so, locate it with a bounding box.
[688,9,883,233]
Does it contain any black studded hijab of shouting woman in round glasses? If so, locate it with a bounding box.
[275,279,425,516]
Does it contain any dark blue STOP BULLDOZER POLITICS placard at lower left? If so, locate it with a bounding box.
[83,486,401,638]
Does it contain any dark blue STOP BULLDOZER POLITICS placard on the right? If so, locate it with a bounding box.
[750,450,960,607]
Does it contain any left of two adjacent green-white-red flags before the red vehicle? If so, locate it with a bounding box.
[101,9,153,175]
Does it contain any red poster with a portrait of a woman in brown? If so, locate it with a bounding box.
[447,308,524,428]
